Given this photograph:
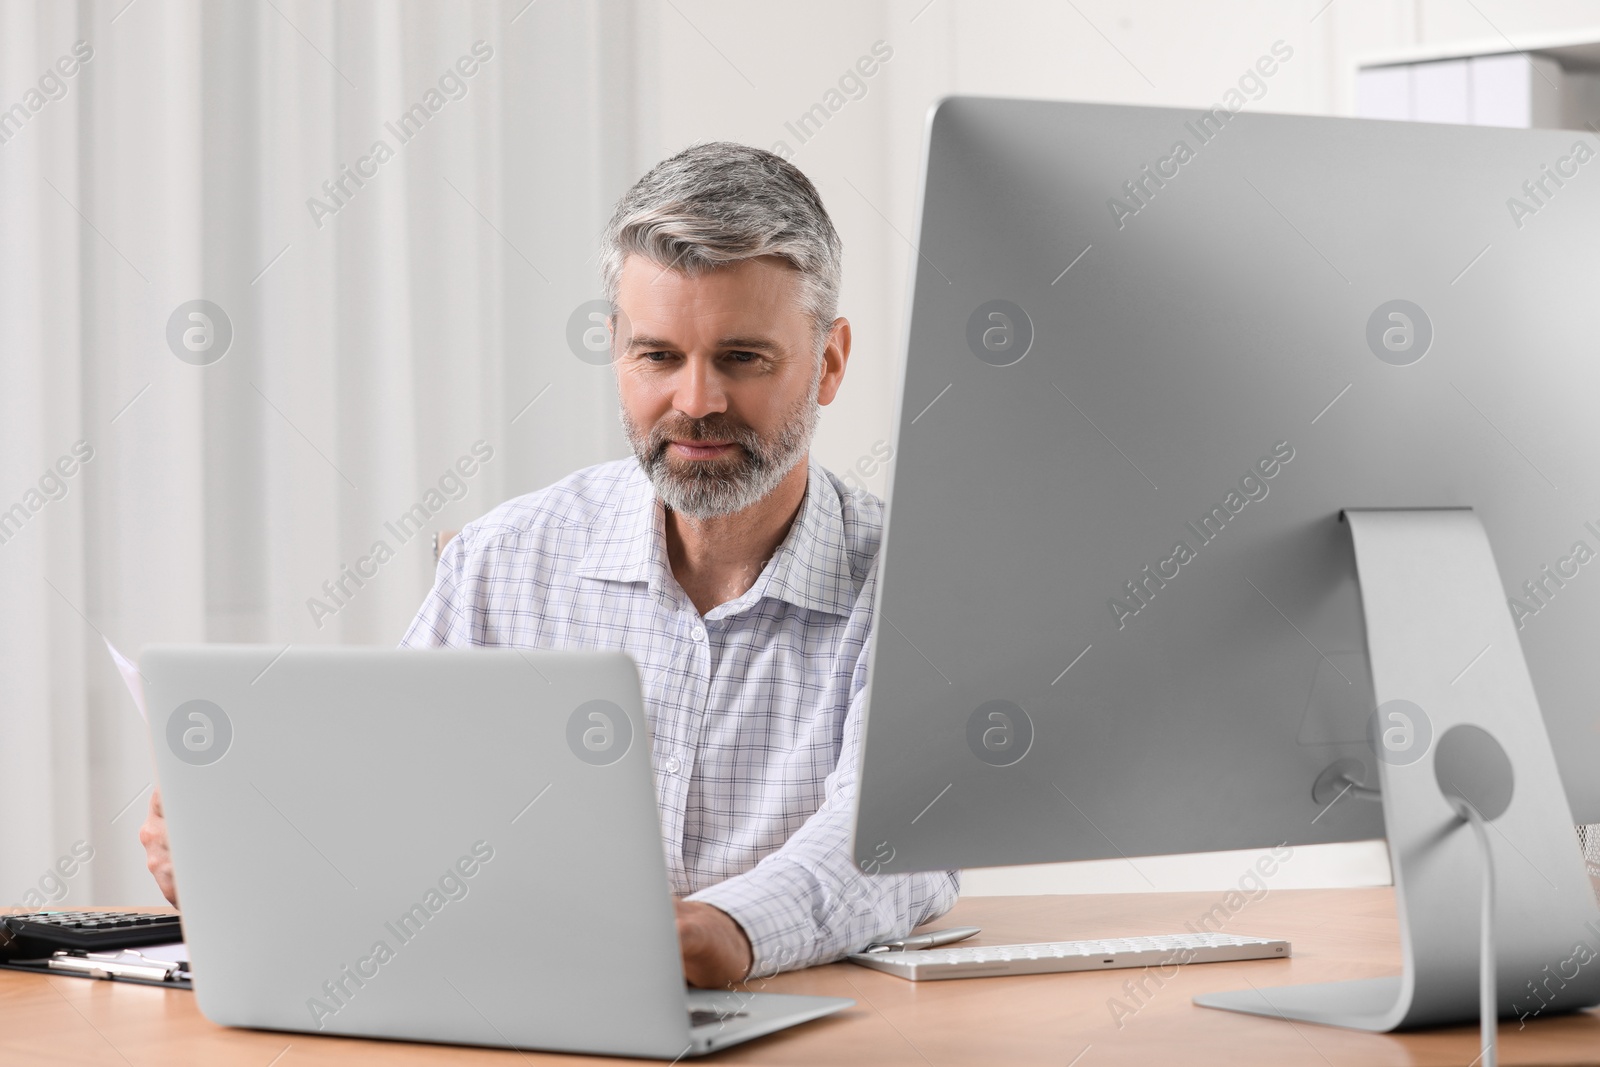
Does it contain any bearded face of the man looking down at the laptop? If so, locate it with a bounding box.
[613,256,850,518]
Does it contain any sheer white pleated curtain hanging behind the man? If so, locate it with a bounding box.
[0,0,653,905]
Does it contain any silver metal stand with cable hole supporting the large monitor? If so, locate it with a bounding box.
[1195,509,1600,1032]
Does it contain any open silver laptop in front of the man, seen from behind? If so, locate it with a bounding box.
[139,645,854,1059]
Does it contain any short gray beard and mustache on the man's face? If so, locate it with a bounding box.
[618,360,822,520]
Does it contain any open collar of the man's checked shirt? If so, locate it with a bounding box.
[578,459,861,619]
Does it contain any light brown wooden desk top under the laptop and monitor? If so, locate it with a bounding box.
[0,888,1600,1067]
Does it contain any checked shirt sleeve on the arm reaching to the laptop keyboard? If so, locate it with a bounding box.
[688,633,960,977]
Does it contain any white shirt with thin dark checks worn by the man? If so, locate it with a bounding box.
[402,459,958,974]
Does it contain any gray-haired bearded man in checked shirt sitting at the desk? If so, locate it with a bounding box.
[141,142,957,987]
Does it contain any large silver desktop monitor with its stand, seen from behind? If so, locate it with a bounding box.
[854,98,1600,1029]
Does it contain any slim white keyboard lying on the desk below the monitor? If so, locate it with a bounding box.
[848,934,1290,982]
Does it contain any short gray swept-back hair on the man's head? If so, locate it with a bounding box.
[600,141,843,350]
